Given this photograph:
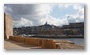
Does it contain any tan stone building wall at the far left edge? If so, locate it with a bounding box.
[4,13,13,39]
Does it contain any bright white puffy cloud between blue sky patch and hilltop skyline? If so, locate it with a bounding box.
[40,16,68,26]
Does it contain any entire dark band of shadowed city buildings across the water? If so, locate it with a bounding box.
[13,22,84,37]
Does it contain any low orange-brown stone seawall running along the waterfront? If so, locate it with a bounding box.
[9,36,84,49]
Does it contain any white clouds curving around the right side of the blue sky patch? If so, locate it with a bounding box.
[55,4,84,23]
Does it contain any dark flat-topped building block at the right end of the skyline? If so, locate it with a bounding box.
[62,22,84,35]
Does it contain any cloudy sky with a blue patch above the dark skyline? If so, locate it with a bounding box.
[4,4,84,27]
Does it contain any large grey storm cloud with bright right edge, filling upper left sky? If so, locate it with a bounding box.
[4,4,52,25]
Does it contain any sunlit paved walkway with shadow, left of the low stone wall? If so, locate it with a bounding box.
[4,40,40,49]
